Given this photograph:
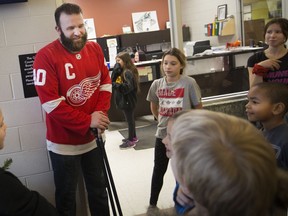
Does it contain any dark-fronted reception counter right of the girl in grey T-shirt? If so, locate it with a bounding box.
[185,47,263,98]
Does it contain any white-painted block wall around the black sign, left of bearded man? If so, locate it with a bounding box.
[0,0,59,206]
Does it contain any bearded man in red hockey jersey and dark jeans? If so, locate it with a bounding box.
[33,3,112,216]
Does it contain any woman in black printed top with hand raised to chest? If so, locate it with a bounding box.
[247,18,288,86]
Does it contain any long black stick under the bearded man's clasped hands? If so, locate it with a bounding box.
[91,128,123,216]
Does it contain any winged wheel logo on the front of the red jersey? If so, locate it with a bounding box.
[66,73,101,106]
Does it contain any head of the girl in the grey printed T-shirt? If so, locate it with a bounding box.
[161,48,186,76]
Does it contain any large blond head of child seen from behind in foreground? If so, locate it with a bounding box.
[171,110,277,216]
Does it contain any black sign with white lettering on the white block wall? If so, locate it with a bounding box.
[18,53,38,98]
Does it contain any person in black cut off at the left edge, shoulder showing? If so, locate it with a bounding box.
[0,110,58,216]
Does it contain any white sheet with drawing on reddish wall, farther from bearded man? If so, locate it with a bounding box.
[132,11,159,33]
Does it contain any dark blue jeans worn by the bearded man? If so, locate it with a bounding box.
[49,148,109,216]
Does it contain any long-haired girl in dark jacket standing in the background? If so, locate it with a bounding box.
[111,52,139,149]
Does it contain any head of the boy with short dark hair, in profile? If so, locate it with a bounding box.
[246,82,288,122]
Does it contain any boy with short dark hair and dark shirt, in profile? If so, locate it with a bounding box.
[246,82,288,170]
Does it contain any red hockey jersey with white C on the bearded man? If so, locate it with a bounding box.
[33,40,112,150]
